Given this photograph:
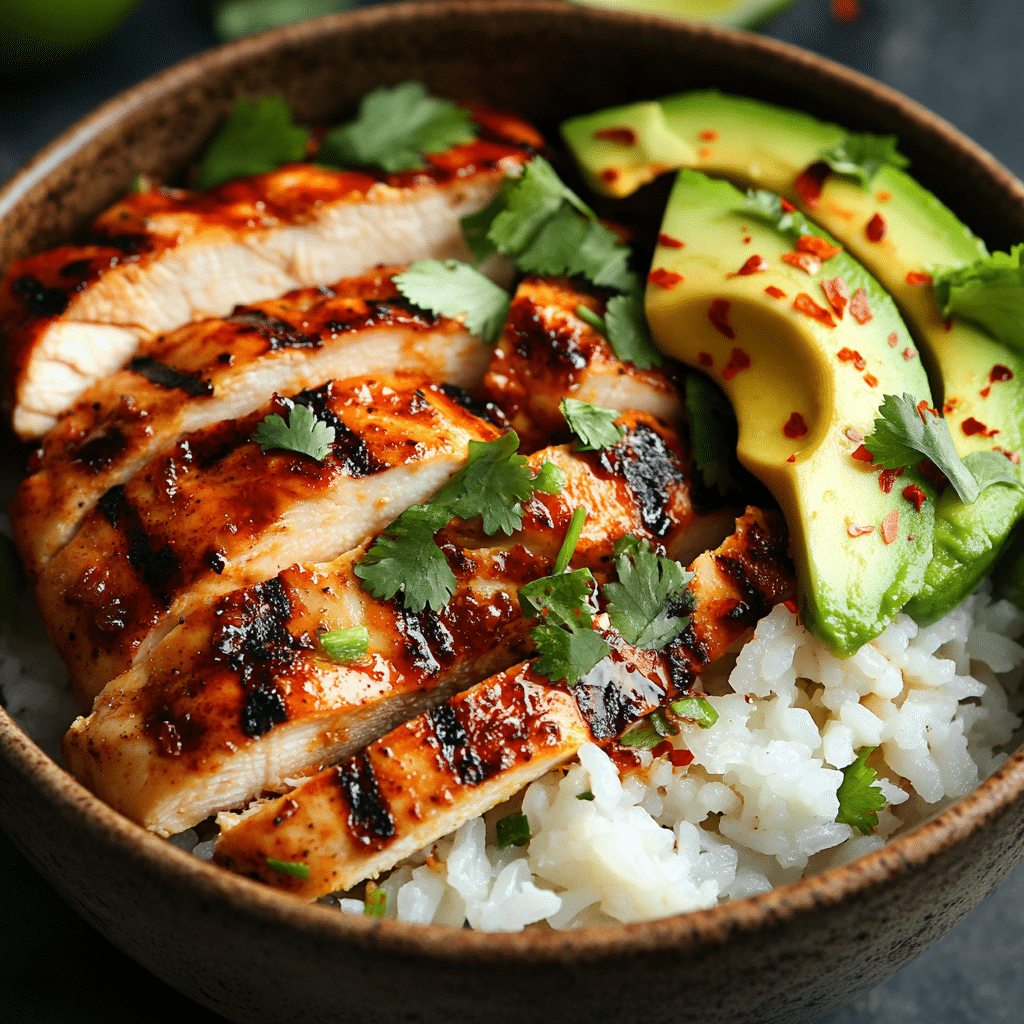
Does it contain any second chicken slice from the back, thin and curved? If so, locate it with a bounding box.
[10,270,490,580]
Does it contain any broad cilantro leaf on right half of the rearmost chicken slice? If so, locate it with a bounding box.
[316,82,476,173]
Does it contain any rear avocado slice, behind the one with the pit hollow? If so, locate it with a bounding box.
[563,91,1024,624]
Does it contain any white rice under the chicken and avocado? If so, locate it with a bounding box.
[0,491,1024,931]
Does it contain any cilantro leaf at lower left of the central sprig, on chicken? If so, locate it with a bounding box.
[354,505,456,612]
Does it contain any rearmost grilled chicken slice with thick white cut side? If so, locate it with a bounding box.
[0,111,543,437]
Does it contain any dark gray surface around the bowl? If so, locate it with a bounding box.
[0,0,1024,1024]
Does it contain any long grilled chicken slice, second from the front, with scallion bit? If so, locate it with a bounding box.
[65,415,731,835]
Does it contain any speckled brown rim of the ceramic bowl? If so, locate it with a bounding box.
[0,0,1024,962]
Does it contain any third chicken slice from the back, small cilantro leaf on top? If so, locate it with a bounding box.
[36,377,499,700]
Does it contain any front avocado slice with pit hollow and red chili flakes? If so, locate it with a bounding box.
[646,170,935,655]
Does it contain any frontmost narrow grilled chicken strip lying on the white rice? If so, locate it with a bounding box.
[214,509,795,899]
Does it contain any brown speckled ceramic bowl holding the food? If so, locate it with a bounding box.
[0,0,1024,1024]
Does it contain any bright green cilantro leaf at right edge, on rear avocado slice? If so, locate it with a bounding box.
[934,244,1024,350]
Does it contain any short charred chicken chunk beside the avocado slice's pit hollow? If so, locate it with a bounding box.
[483,278,683,452]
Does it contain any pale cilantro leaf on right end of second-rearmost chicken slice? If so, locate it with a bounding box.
[394,259,510,344]
